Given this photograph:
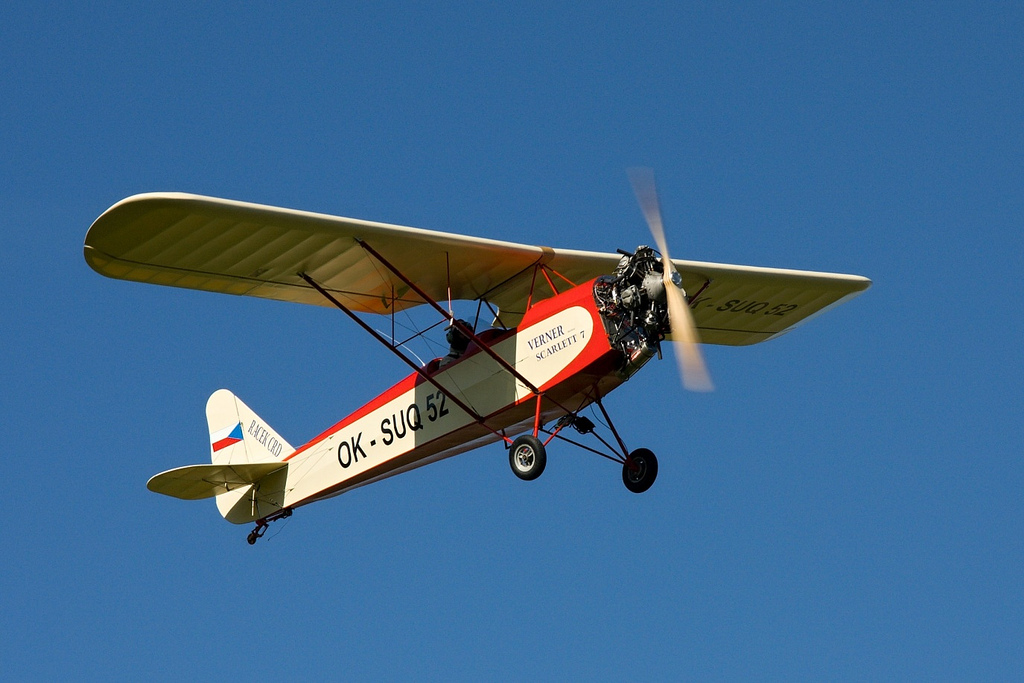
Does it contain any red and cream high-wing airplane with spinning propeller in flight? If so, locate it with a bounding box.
[85,170,871,545]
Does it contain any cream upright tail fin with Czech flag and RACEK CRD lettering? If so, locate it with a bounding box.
[206,389,295,465]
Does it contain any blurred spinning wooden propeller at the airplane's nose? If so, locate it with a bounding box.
[628,168,714,391]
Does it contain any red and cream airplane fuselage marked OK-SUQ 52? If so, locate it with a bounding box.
[272,274,635,508]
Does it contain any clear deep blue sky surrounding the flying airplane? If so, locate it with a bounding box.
[0,2,1024,680]
